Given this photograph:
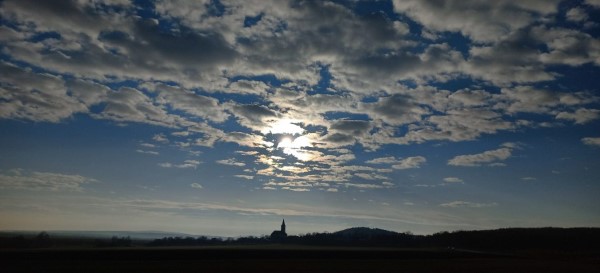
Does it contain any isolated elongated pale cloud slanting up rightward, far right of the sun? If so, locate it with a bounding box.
[448,143,517,167]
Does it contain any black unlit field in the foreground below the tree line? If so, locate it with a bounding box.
[0,246,600,273]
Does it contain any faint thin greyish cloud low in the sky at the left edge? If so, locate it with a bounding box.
[0,169,98,192]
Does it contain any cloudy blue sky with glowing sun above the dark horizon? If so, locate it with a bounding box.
[0,0,600,236]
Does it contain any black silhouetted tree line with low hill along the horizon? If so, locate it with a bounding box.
[0,227,600,250]
